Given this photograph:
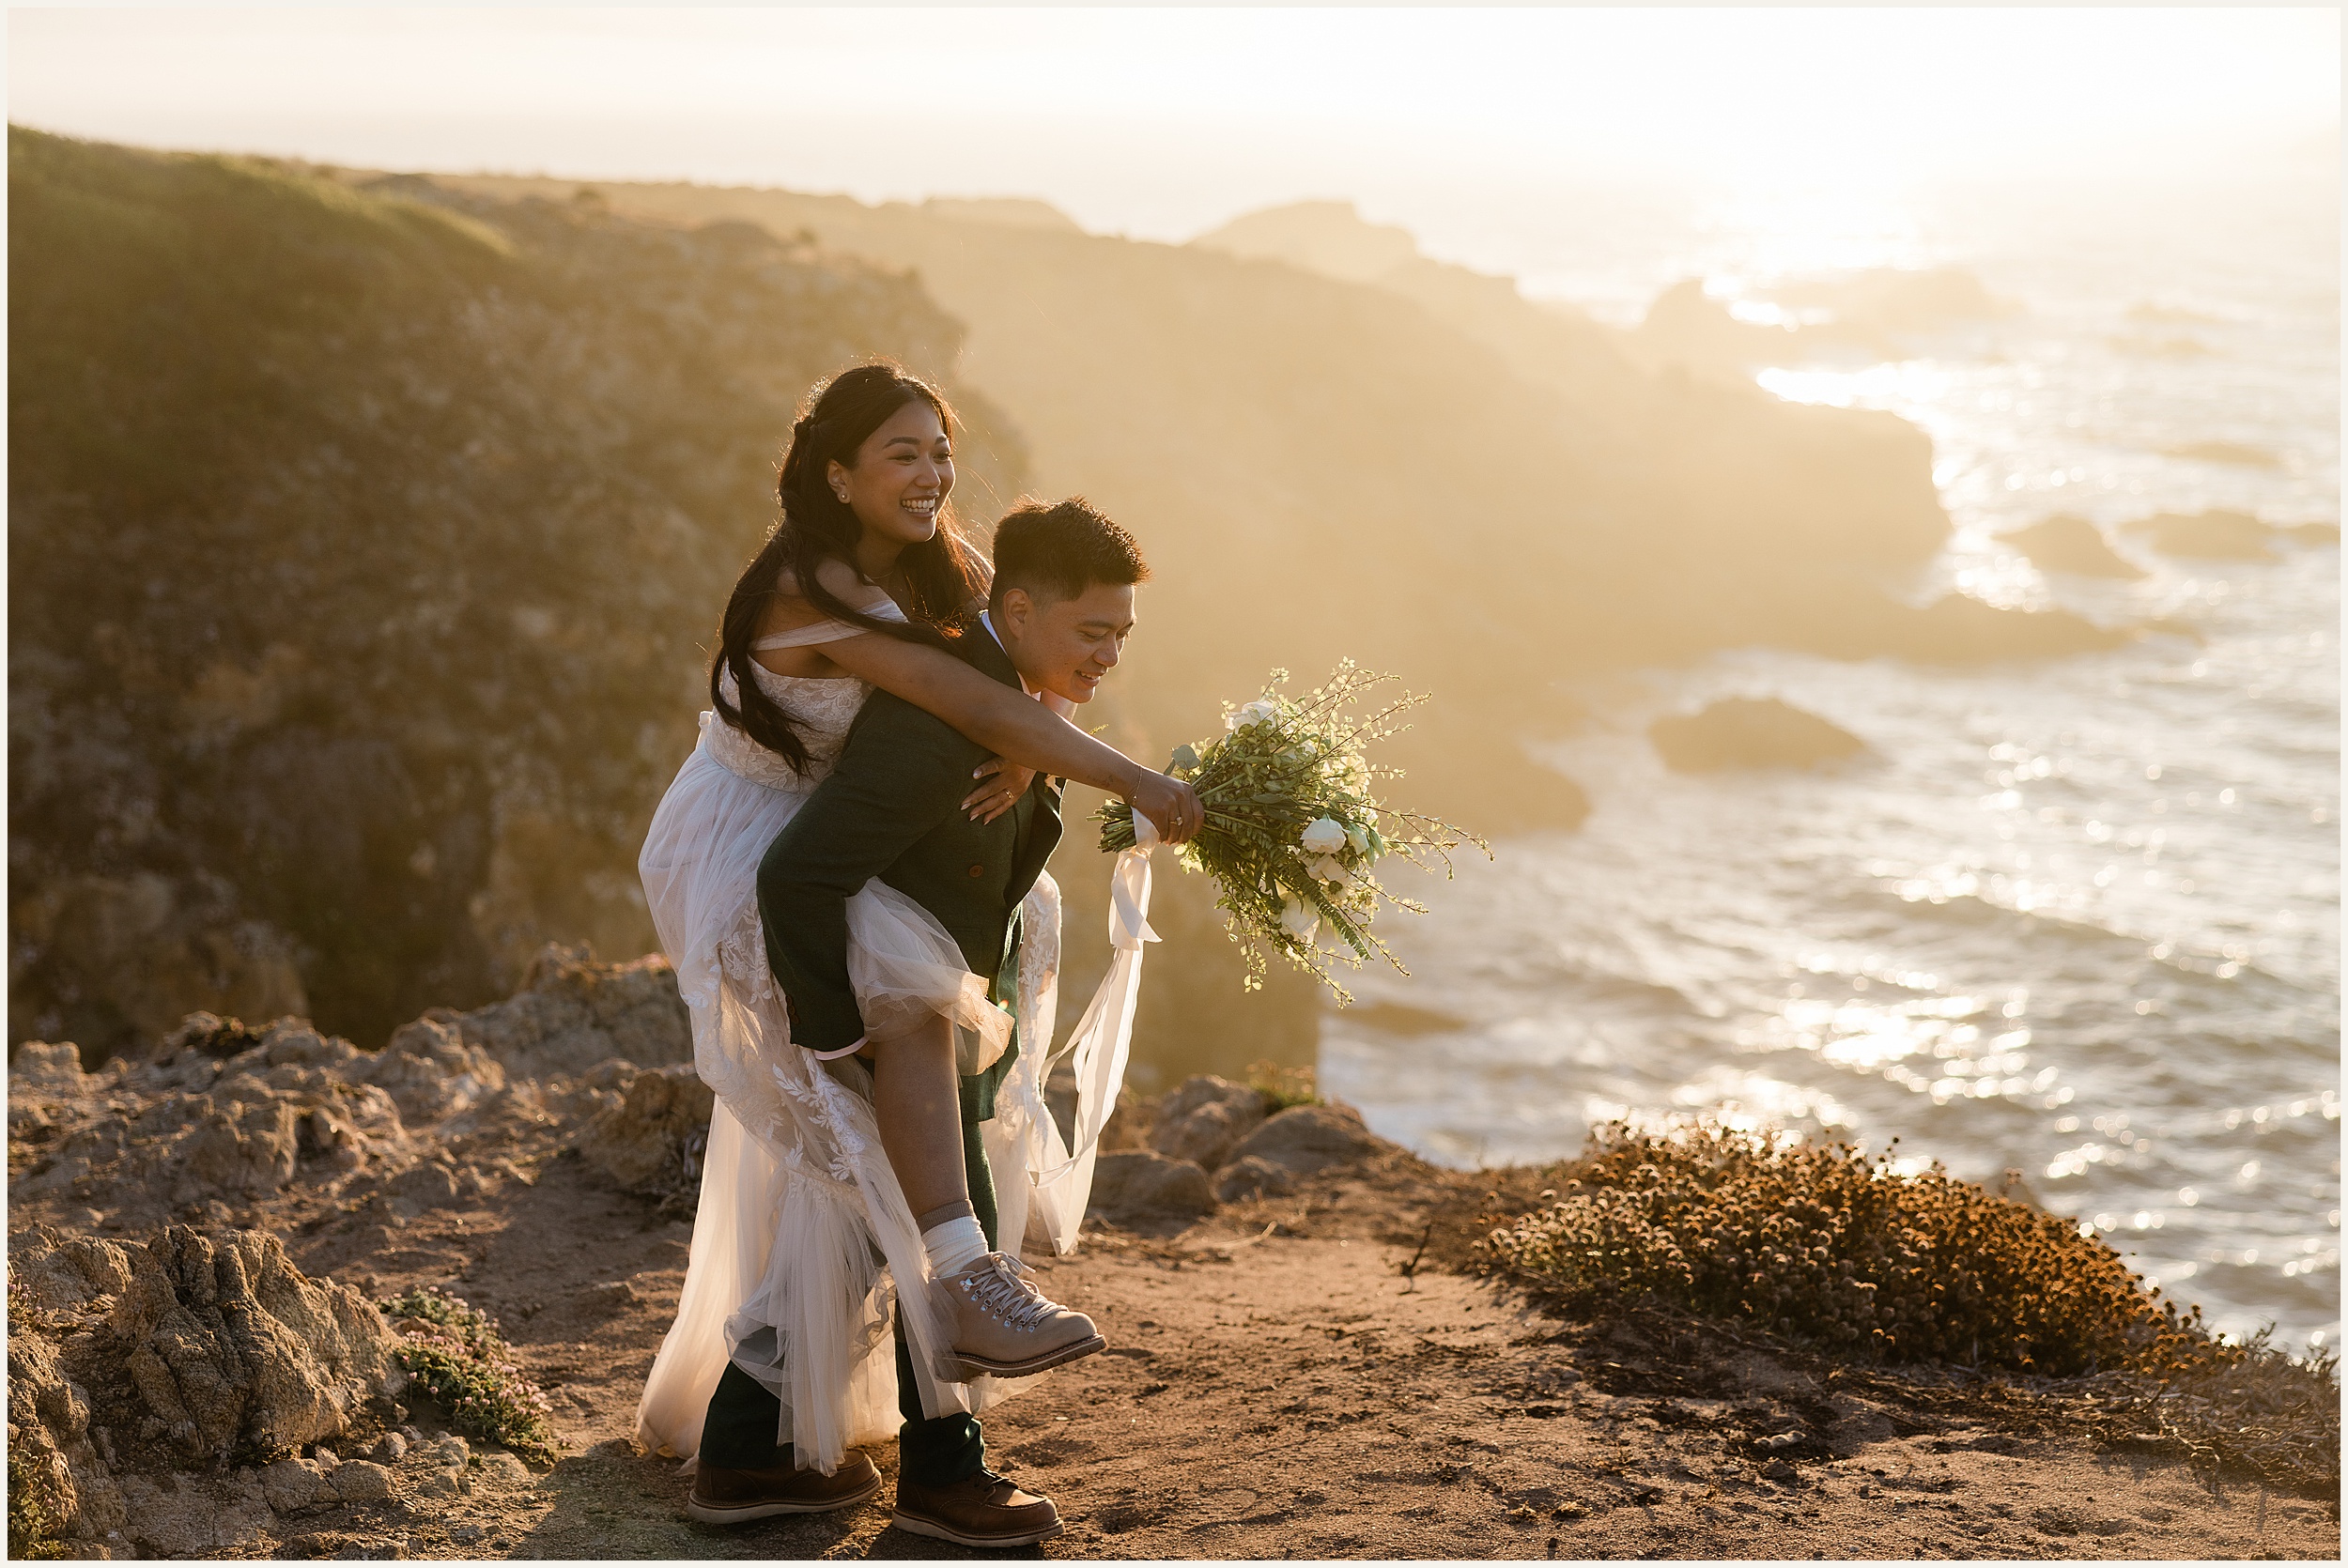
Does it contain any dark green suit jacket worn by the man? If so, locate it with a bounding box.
[759,620,1061,1120]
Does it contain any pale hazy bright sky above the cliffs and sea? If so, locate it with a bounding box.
[8,8,2341,239]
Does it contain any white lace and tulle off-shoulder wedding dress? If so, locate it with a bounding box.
[637,606,1155,1474]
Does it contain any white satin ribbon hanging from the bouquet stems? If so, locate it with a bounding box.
[1022,812,1158,1258]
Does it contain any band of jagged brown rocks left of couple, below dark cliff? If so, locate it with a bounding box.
[9,948,709,1230]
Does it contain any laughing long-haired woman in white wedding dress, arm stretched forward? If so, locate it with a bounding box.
[637,364,1200,1545]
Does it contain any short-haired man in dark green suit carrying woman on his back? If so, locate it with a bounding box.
[690,498,1149,1547]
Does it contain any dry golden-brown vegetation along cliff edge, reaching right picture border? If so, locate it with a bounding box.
[1477,1125,2339,1486]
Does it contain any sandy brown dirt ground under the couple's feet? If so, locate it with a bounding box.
[272,1162,2339,1559]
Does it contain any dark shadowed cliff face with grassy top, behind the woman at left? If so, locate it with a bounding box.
[9,130,1022,1061]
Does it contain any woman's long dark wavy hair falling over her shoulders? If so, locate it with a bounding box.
[709,361,989,773]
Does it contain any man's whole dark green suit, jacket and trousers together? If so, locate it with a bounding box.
[700,620,1061,1486]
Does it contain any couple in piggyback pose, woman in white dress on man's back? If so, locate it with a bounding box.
[639,364,1200,1547]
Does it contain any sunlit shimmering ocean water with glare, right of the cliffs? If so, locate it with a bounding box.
[1322,171,2341,1347]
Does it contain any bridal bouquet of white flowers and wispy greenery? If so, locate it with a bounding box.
[1094,660,1491,1005]
